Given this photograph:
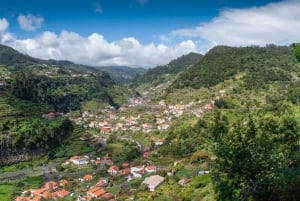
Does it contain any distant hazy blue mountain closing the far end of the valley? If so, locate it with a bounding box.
[97,66,146,85]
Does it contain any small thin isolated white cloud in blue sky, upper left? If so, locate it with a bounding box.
[18,14,44,31]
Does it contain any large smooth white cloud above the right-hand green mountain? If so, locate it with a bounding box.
[171,0,300,46]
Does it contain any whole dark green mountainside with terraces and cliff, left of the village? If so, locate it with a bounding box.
[0,45,127,166]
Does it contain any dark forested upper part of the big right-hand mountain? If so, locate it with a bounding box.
[171,45,298,88]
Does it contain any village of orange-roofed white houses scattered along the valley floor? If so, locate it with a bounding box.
[15,91,213,201]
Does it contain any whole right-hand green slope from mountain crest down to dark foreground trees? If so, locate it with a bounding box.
[157,45,300,201]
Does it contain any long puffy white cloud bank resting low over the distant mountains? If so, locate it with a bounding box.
[0,31,196,67]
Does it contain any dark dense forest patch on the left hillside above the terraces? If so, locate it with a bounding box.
[11,71,119,113]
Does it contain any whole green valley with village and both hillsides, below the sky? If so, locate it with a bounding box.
[0,45,300,201]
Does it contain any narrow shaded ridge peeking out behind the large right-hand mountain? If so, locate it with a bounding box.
[132,52,202,86]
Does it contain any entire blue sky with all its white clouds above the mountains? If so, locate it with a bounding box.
[0,0,300,68]
